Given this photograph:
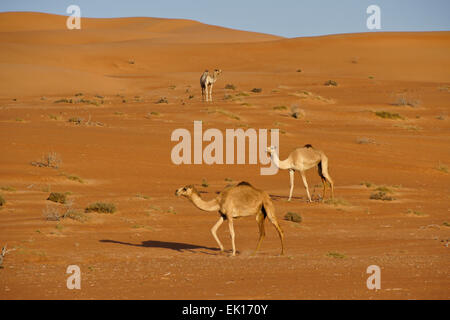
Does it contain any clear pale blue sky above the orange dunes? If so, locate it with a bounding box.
[0,0,450,37]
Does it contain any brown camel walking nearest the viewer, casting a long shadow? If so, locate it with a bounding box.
[175,181,284,256]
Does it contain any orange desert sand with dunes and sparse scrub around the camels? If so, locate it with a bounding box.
[0,12,450,299]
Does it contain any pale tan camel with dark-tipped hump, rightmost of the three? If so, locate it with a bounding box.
[267,144,334,202]
